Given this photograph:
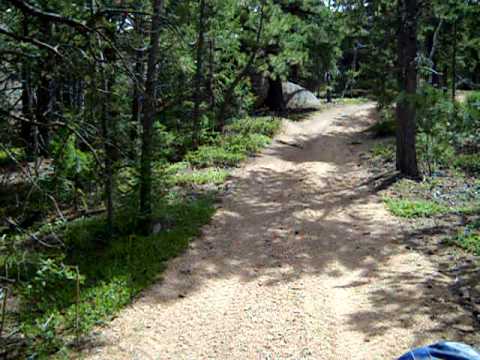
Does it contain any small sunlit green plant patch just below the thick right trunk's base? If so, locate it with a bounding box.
[384,198,449,219]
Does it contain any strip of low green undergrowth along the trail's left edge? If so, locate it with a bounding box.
[0,117,281,358]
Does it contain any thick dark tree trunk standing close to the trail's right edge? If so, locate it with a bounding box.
[396,0,419,178]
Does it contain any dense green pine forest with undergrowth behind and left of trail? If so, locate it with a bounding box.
[0,0,480,356]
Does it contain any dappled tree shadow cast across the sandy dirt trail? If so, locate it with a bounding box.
[103,105,474,352]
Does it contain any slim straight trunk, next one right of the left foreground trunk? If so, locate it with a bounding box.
[192,0,206,149]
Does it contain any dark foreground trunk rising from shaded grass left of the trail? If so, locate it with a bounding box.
[140,0,163,234]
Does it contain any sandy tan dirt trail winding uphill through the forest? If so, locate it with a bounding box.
[86,104,464,360]
